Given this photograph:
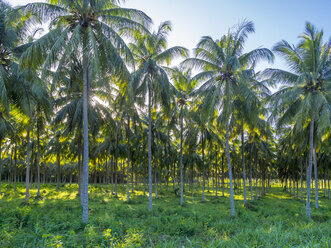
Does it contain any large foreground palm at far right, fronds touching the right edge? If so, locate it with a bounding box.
[265,23,331,218]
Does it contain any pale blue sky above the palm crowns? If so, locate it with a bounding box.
[7,0,331,70]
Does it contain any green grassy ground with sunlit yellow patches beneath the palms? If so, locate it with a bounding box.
[0,184,331,247]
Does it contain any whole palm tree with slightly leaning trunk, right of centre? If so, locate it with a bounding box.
[183,21,273,216]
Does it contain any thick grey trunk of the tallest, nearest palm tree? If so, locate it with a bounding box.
[83,50,89,223]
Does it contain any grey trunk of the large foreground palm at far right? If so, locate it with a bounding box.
[307,105,315,219]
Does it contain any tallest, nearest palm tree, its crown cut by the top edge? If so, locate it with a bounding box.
[21,0,151,222]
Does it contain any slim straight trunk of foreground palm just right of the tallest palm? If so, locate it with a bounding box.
[148,85,153,211]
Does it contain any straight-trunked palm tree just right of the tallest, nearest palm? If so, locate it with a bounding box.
[130,22,188,211]
